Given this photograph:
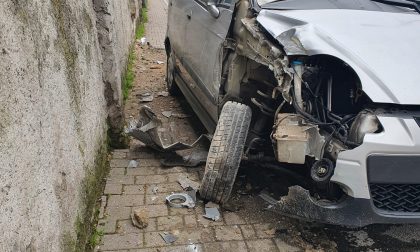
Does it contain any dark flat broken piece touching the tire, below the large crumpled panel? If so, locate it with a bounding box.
[160,150,208,167]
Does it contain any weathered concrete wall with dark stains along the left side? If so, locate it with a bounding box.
[0,0,139,251]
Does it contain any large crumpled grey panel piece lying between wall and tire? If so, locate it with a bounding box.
[127,106,210,152]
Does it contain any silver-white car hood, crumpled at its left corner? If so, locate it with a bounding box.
[257,9,420,105]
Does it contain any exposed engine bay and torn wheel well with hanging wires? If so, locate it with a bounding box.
[220,1,383,201]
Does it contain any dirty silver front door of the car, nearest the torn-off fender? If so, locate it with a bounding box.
[182,0,234,128]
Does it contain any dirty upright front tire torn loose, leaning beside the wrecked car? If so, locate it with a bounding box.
[200,102,252,204]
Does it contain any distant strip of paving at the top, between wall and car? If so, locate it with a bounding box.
[146,0,168,49]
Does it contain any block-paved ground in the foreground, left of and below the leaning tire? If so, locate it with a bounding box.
[96,147,296,252]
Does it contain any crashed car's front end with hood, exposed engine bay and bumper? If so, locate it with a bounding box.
[222,1,420,226]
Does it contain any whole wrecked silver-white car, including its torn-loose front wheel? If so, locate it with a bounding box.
[165,0,420,226]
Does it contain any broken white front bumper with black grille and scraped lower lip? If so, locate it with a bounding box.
[277,113,420,226]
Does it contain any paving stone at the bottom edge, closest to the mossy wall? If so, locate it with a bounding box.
[100,233,143,250]
